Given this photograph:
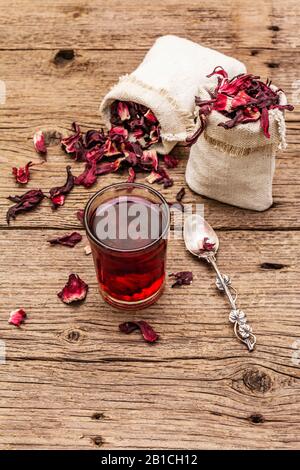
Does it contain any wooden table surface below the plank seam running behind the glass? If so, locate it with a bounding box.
[0,230,300,448]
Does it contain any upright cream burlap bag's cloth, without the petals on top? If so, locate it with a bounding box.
[186,87,287,211]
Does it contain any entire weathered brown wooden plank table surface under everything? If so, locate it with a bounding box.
[0,0,300,449]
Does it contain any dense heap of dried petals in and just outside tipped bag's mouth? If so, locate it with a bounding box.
[61,101,178,188]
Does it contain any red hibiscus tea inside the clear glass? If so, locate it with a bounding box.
[90,196,168,308]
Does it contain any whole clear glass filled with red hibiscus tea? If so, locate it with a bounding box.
[84,183,170,309]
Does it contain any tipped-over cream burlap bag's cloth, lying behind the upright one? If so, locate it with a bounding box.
[100,36,246,154]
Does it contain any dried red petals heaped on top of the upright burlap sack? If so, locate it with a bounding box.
[186,66,294,145]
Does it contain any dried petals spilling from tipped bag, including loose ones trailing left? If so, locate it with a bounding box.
[7,101,178,223]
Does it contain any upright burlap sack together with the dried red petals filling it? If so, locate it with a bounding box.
[186,67,293,211]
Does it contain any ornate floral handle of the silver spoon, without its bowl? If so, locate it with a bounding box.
[207,255,256,351]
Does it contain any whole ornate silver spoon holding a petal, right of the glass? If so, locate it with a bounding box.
[184,214,256,351]
